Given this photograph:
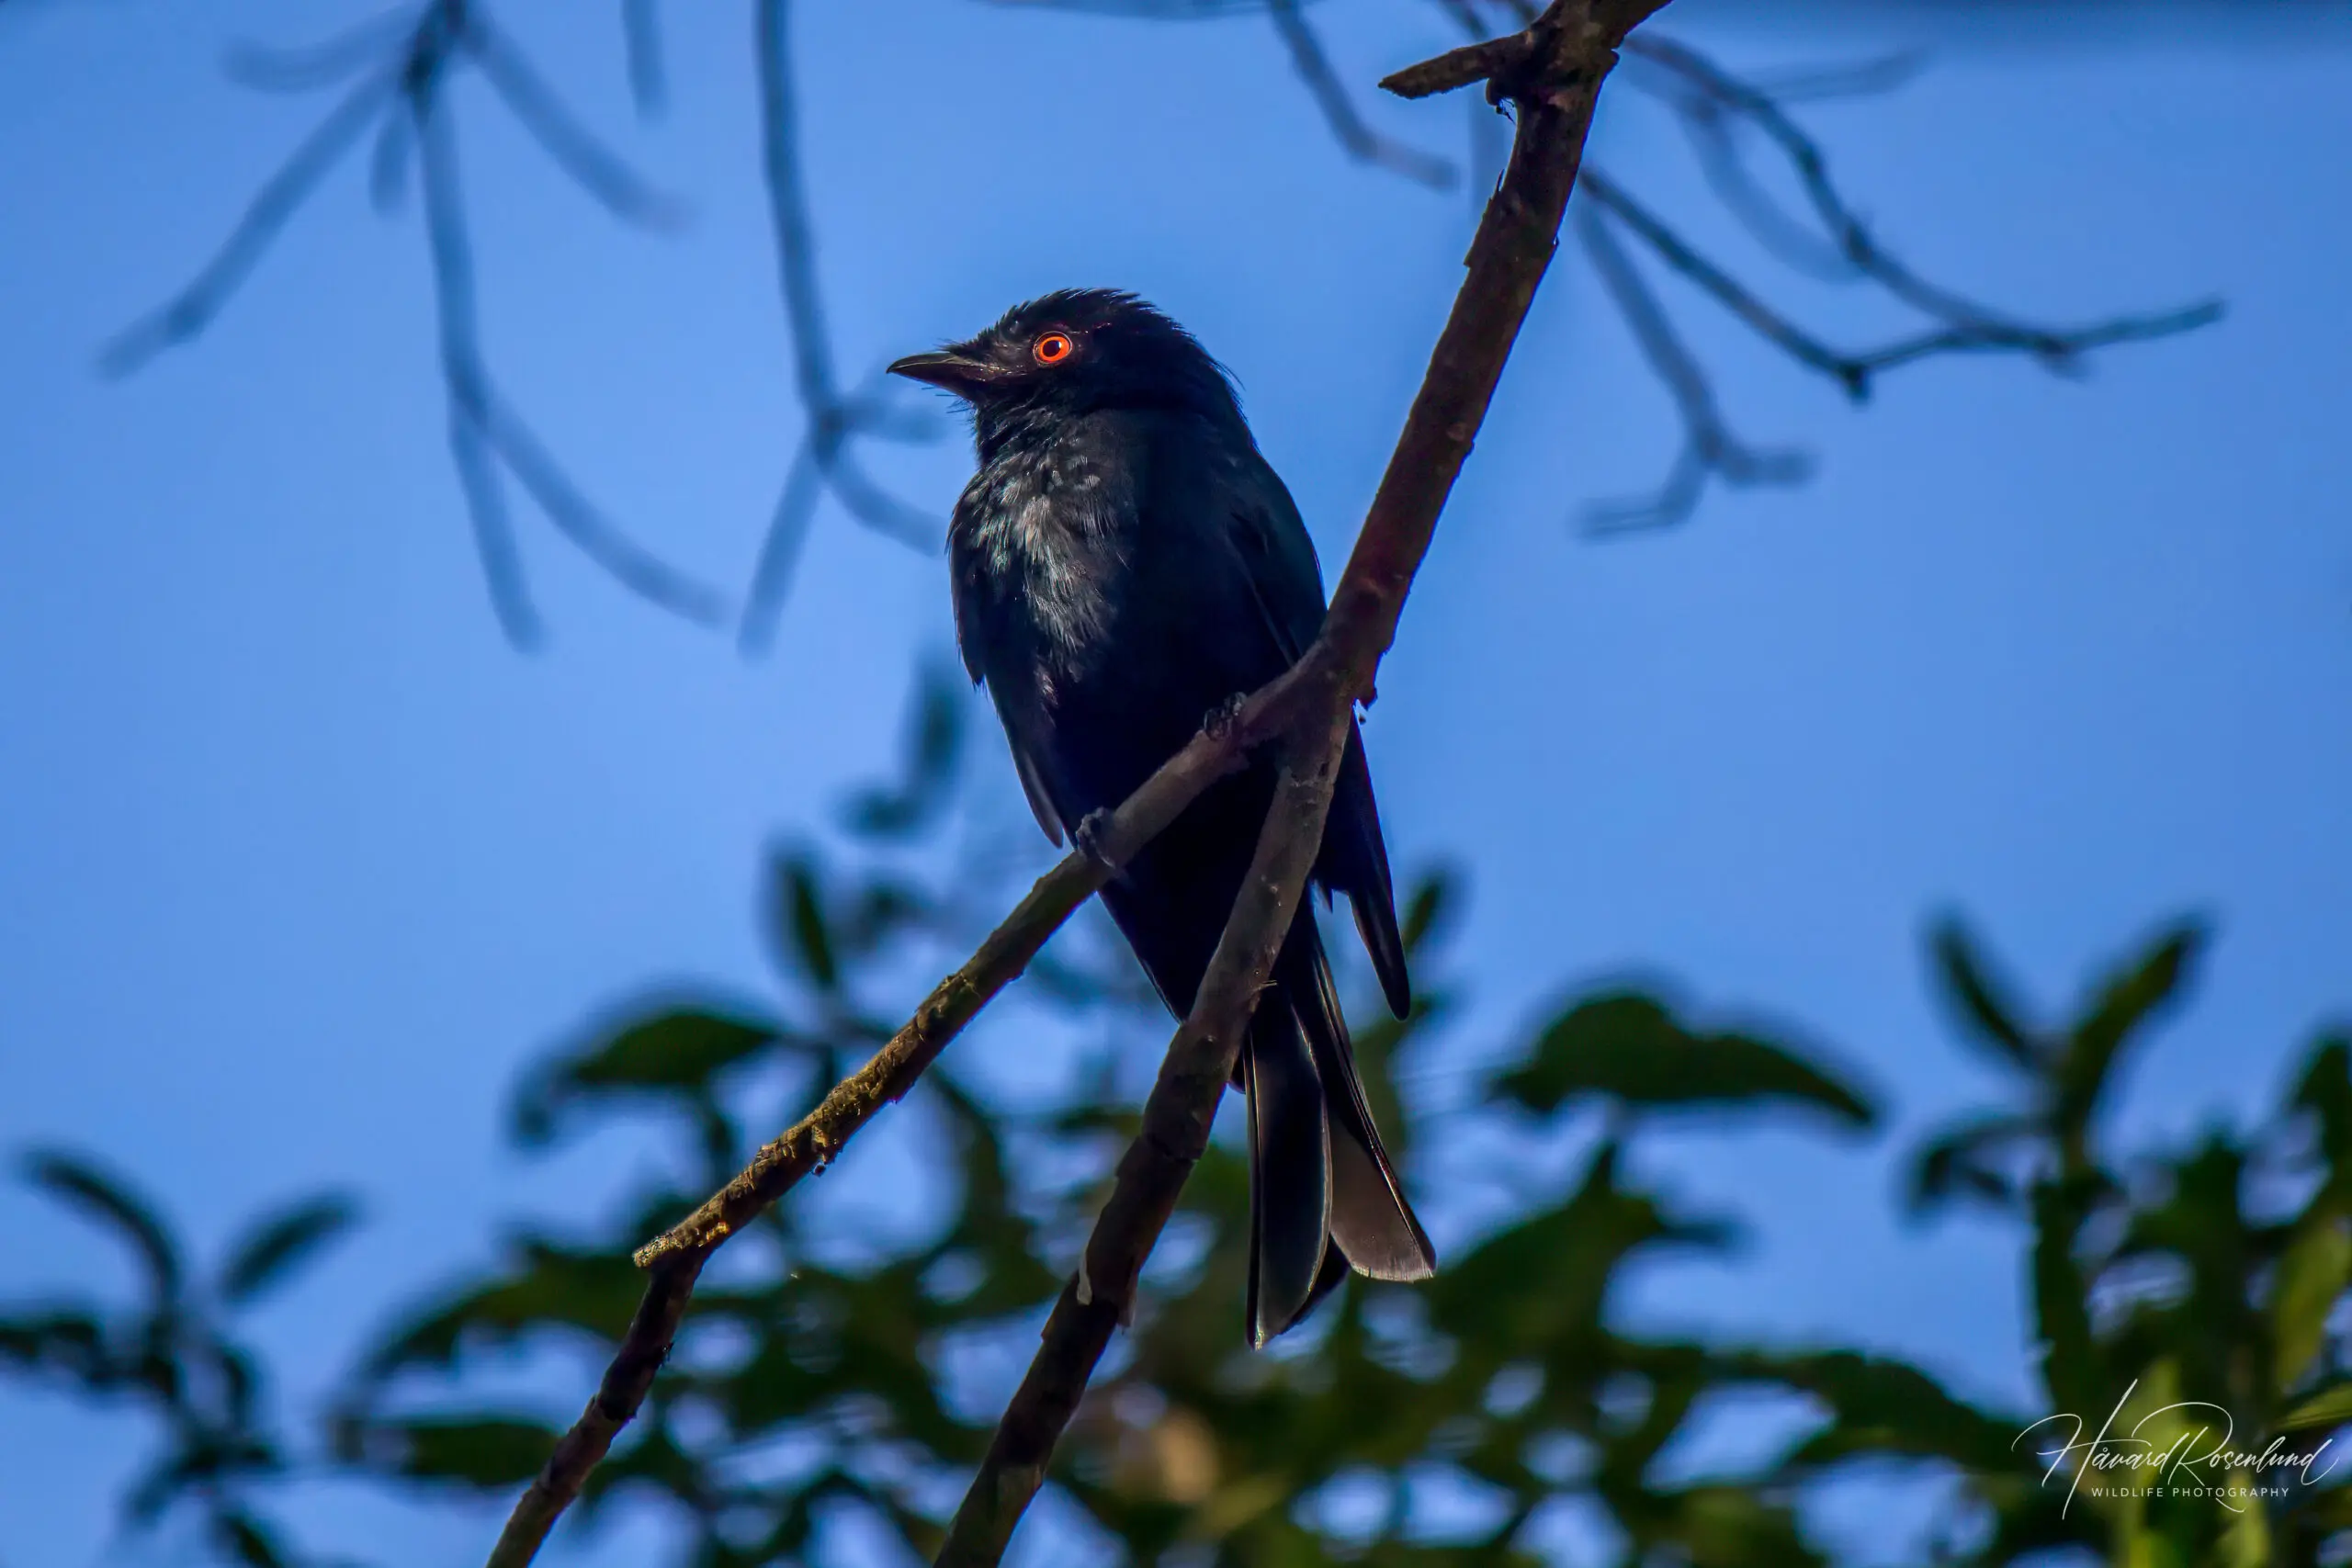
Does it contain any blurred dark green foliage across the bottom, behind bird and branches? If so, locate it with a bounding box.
[14,672,2352,1568]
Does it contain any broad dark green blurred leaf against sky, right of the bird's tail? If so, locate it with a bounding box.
[1491,992,1877,1126]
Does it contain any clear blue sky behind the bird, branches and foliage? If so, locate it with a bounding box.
[0,0,2352,1563]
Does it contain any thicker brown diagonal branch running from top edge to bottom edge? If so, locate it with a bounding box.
[938,0,1663,1568]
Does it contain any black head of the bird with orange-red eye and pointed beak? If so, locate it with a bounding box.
[889,289,1242,451]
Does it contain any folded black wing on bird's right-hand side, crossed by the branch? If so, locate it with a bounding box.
[1226,454,1414,1018]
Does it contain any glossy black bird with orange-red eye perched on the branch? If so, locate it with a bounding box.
[889,289,1437,1345]
